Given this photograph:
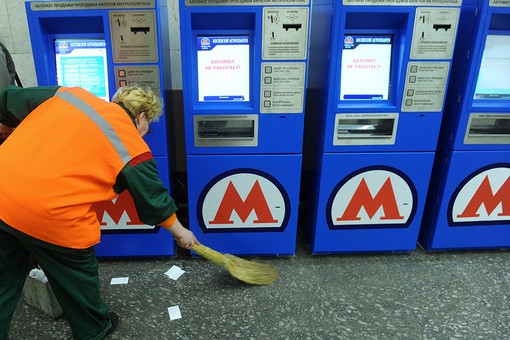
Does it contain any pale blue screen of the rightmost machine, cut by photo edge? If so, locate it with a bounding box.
[474,34,510,99]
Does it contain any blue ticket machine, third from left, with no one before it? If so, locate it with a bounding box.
[301,0,460,254]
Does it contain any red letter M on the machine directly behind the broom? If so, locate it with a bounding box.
[209,181,278,224]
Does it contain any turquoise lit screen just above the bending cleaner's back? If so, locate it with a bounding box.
[55,39,110,100]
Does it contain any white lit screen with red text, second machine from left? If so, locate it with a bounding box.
[197,35,250,102]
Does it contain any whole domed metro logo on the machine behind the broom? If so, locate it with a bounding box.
[197,169,290,232]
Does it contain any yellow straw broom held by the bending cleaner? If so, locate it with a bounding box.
[191,244,278,285]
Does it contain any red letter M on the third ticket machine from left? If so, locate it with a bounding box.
[336,177,404,221]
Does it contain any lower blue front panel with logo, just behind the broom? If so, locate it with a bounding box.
[187,155,301,255]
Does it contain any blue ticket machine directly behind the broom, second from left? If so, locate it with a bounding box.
[180,0,310,255]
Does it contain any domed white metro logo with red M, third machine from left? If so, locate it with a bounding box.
[326,167,417,229]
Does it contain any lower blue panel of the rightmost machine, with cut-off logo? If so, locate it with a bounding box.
[420,149,510,250]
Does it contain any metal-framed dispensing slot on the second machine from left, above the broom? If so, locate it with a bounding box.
[194,115,258,147]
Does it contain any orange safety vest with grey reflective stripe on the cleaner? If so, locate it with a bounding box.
[0,87,150,249]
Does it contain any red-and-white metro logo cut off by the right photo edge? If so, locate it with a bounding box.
[448,165,510,226]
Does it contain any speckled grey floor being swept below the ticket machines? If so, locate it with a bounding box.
[6,234,510,340]
